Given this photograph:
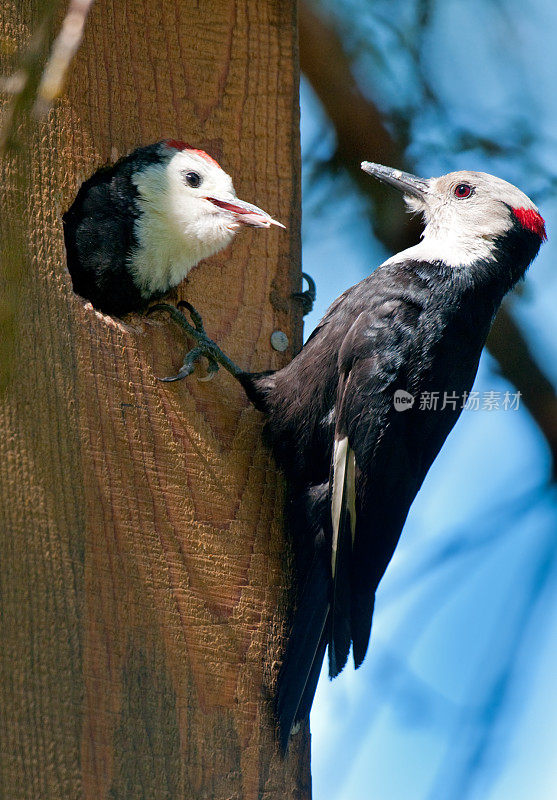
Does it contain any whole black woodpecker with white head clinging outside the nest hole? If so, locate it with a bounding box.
[150,162,546,747]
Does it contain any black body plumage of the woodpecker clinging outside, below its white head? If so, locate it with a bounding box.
[248,220,540,746]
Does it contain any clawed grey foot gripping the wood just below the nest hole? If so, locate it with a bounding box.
[147,300,242,383]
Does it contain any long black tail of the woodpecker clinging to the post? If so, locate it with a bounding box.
[276,549,331,752]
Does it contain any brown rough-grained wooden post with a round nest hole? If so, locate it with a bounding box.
[0,0,310,800]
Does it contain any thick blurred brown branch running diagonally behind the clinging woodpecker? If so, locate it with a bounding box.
[299,0,557,472]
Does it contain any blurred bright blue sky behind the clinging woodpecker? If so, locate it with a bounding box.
[301,0,557,800]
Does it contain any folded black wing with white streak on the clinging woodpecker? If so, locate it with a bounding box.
[329,298,422,677]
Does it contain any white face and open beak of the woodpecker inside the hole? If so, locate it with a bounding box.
[128,145,283,296]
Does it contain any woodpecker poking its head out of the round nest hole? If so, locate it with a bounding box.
[62,139,284,316]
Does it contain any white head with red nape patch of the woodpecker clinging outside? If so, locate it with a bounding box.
[362,161,547,277]
